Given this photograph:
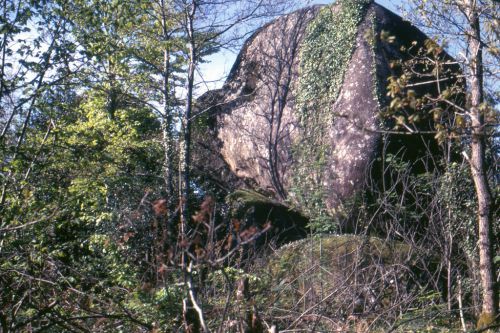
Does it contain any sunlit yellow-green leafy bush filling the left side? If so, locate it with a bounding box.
[0,86,161,331]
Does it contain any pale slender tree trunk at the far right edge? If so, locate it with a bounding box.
[465,0,498,326]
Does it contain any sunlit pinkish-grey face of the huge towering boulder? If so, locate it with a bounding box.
[198,0,450,223]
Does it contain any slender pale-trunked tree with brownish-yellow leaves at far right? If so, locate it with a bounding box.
[390,0,500,327]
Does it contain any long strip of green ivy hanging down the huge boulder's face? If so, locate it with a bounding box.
[291,0,372,232]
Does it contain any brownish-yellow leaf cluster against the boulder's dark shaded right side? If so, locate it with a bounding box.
[380,34,464,144]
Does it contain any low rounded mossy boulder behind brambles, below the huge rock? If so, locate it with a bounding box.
[252,236,439,331]
